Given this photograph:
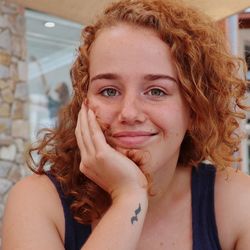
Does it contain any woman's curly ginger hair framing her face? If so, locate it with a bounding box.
[29,0,247,224]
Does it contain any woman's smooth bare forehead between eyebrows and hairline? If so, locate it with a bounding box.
[89,25,176,73]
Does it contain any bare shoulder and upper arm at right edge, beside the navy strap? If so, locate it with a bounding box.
[215,168,250,249]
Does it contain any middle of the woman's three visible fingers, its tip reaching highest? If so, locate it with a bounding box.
[79,104,95,155]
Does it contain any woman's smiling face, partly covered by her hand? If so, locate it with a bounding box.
[87,24,189,176]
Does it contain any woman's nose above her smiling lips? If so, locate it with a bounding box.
[118,96,146,125]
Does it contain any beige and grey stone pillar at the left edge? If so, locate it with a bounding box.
[0,0,30,248]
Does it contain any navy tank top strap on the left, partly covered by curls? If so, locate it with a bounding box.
[46,172,91,250]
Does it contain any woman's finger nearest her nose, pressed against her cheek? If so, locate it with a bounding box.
[88,109,108,151]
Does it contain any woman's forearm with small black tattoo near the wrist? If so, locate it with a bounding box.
[82,191,148,250]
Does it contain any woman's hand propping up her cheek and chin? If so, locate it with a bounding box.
[75,104,147,199]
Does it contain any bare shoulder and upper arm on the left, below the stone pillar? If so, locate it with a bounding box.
[3,175,64,250]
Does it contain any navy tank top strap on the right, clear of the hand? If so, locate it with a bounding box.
[191,163,221,250]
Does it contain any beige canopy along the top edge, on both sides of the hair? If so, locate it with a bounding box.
[7,0,250,24]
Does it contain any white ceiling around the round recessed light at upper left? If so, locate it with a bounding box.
[25,10,82,80]
